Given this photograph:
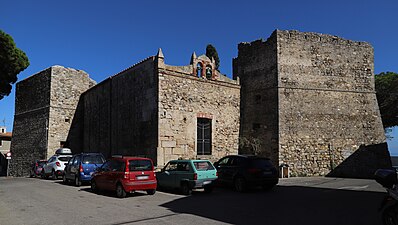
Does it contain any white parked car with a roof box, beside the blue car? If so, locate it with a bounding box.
[41,148,72,180]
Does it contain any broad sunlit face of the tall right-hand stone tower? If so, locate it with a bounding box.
[277,31,385,175]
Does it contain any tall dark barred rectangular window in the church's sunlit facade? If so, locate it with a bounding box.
[197,118,211,155]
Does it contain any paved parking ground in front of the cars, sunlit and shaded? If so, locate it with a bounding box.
[0,177,384,225]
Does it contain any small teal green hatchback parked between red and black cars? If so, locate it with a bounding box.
[156,160,217,195]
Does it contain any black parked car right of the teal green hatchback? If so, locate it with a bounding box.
[214,155,279,192]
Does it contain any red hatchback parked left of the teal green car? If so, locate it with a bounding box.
[91,156,157,198]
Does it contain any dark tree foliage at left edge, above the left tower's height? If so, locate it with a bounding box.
[0,30,29,100]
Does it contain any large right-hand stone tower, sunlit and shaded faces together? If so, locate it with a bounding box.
[234,30,391,177]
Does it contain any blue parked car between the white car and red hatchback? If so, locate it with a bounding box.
[63,153,105,187]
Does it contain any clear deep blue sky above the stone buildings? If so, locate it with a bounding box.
[0,0,398,155]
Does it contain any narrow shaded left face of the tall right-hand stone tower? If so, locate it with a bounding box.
[233,33,279,165]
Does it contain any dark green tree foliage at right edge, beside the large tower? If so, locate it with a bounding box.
[375,72,398,128]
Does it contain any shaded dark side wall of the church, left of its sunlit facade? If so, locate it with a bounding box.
[68,57,158,162]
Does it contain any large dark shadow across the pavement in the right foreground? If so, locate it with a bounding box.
[161,186,384,225]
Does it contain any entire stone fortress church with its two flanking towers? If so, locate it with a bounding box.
[11,30,391,177]
